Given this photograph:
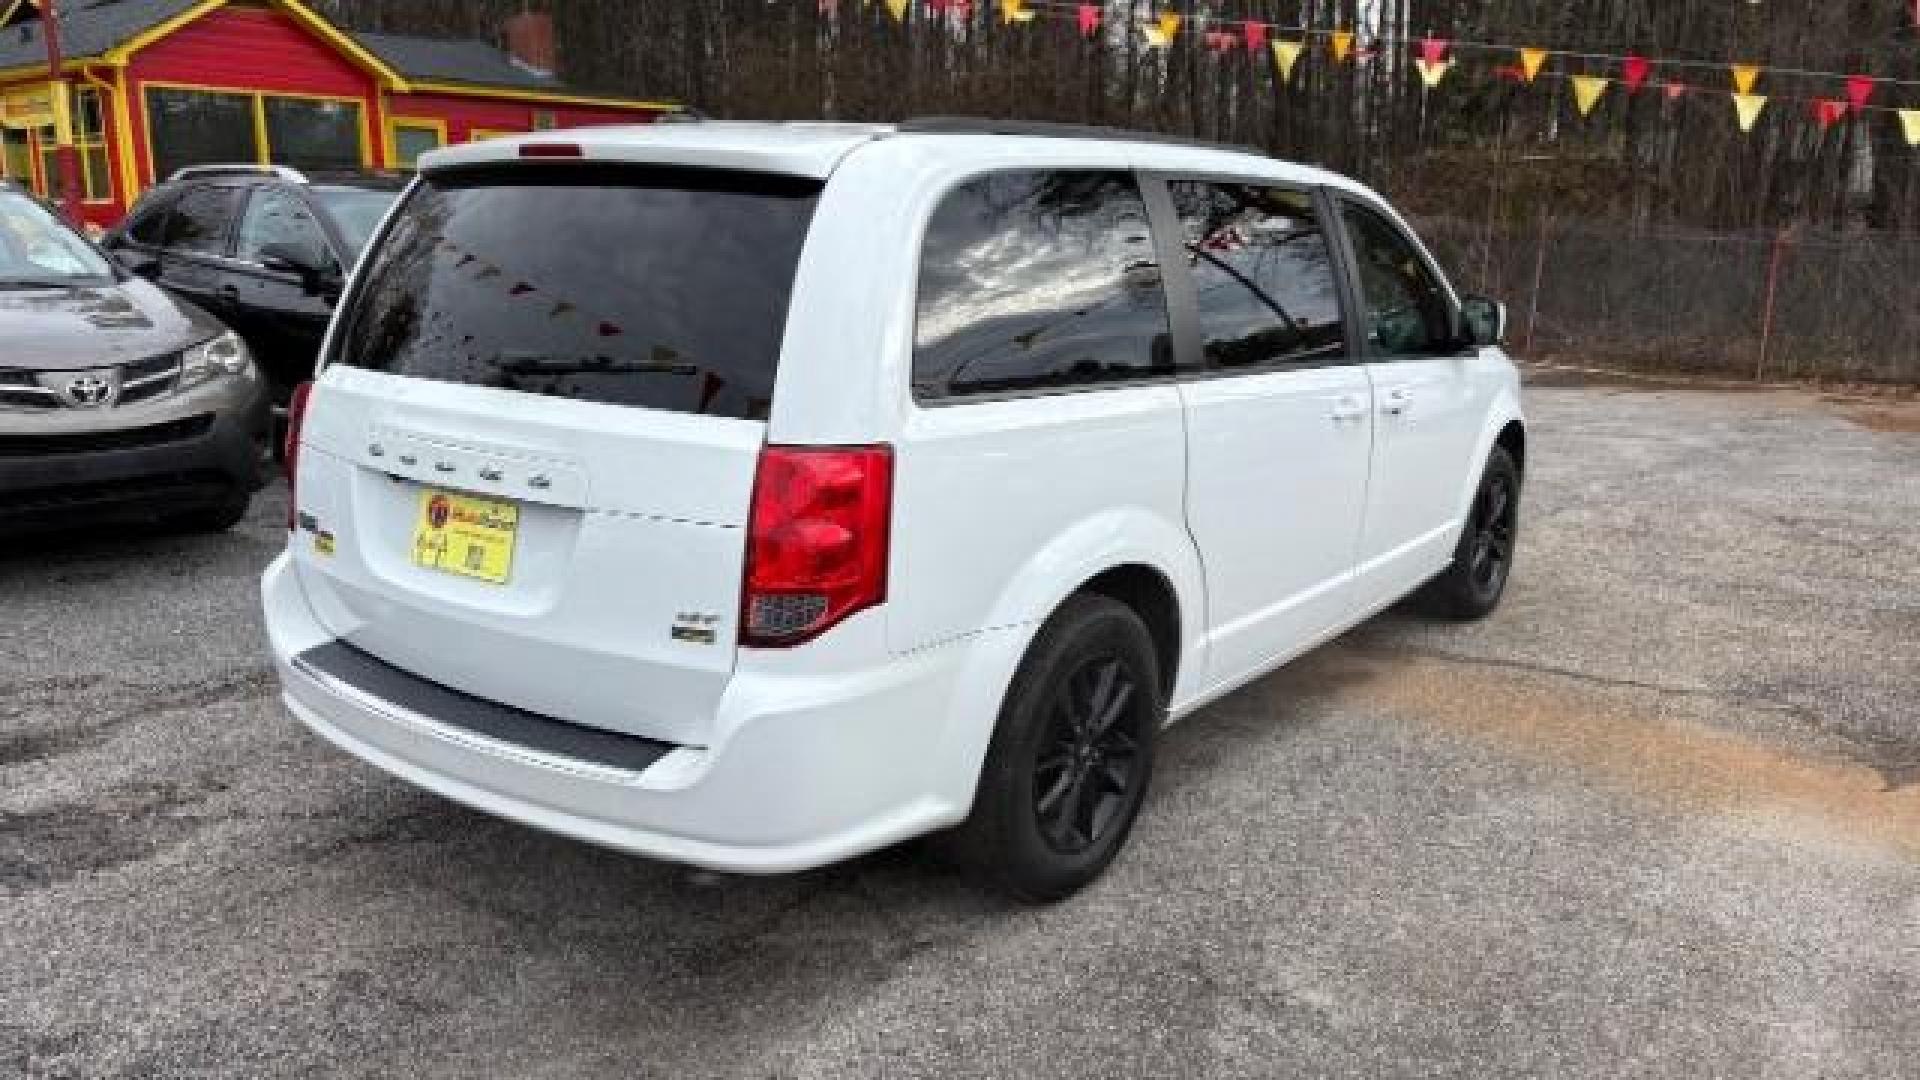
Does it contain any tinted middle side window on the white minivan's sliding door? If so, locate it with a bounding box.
[1169,181,1346,367]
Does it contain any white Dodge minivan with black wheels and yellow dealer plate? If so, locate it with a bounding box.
[263,119,1526,899]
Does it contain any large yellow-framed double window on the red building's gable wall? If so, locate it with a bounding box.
[146,86,367,181]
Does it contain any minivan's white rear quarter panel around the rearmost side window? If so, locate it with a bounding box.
[770,138,1204,699]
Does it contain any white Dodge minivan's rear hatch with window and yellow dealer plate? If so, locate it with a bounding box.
[296,161,820,746]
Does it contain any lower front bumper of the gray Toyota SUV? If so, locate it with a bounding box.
[0,384,271,534]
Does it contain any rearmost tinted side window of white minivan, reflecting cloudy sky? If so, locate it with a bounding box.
[914,171,1173,402]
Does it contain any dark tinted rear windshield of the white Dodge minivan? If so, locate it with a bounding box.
[332,163,820,419]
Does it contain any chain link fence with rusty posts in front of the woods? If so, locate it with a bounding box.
[1419,219,1920,384]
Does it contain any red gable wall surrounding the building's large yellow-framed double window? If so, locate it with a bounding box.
[127,8,386,184]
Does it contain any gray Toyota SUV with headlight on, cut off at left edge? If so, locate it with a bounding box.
[0,183,271,536]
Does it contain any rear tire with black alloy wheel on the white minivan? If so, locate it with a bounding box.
[954,596,1165,903]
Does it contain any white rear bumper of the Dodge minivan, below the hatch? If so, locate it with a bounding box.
[263,555,991,874]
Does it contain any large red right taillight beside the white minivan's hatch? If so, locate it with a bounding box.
[741,446,893,648]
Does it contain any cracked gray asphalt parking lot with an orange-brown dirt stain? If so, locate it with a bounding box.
[0,384,1920,1076]
